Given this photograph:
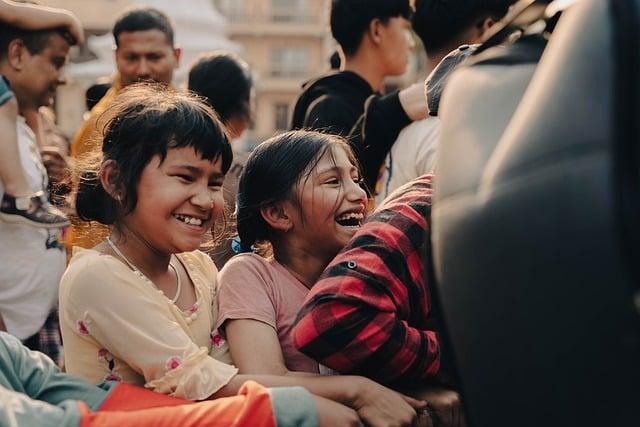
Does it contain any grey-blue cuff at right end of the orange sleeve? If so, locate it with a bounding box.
[269,387,318,427]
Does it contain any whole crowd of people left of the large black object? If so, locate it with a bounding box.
[0,0,514,427]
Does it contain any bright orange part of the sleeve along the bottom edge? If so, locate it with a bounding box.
[79,381,276,427]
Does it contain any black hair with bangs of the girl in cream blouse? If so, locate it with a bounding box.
[75,83,233,225]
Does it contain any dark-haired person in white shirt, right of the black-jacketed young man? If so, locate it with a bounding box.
[375,0,515,205]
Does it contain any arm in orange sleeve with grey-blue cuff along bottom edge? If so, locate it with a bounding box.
[82,382,336,427]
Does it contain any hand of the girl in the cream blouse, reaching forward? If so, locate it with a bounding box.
[350,377,427,427]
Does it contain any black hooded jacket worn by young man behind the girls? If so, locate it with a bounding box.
[291,71,410,189]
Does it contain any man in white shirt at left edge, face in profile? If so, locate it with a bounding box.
[0,21,73,360]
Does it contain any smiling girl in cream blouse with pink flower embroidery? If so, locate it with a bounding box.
[60,85,425,426]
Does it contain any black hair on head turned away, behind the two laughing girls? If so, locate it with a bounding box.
[188,51,253,123]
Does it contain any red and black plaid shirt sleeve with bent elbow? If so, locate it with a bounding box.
[293,175,440,383]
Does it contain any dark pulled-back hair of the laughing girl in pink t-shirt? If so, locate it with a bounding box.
[237,130,358,251]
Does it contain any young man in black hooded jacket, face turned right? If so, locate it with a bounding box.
[292,0,426,188]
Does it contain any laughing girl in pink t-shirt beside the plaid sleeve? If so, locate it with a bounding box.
[218,131,367,375]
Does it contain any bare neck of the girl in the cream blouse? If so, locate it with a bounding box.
[110,225,171,281]
